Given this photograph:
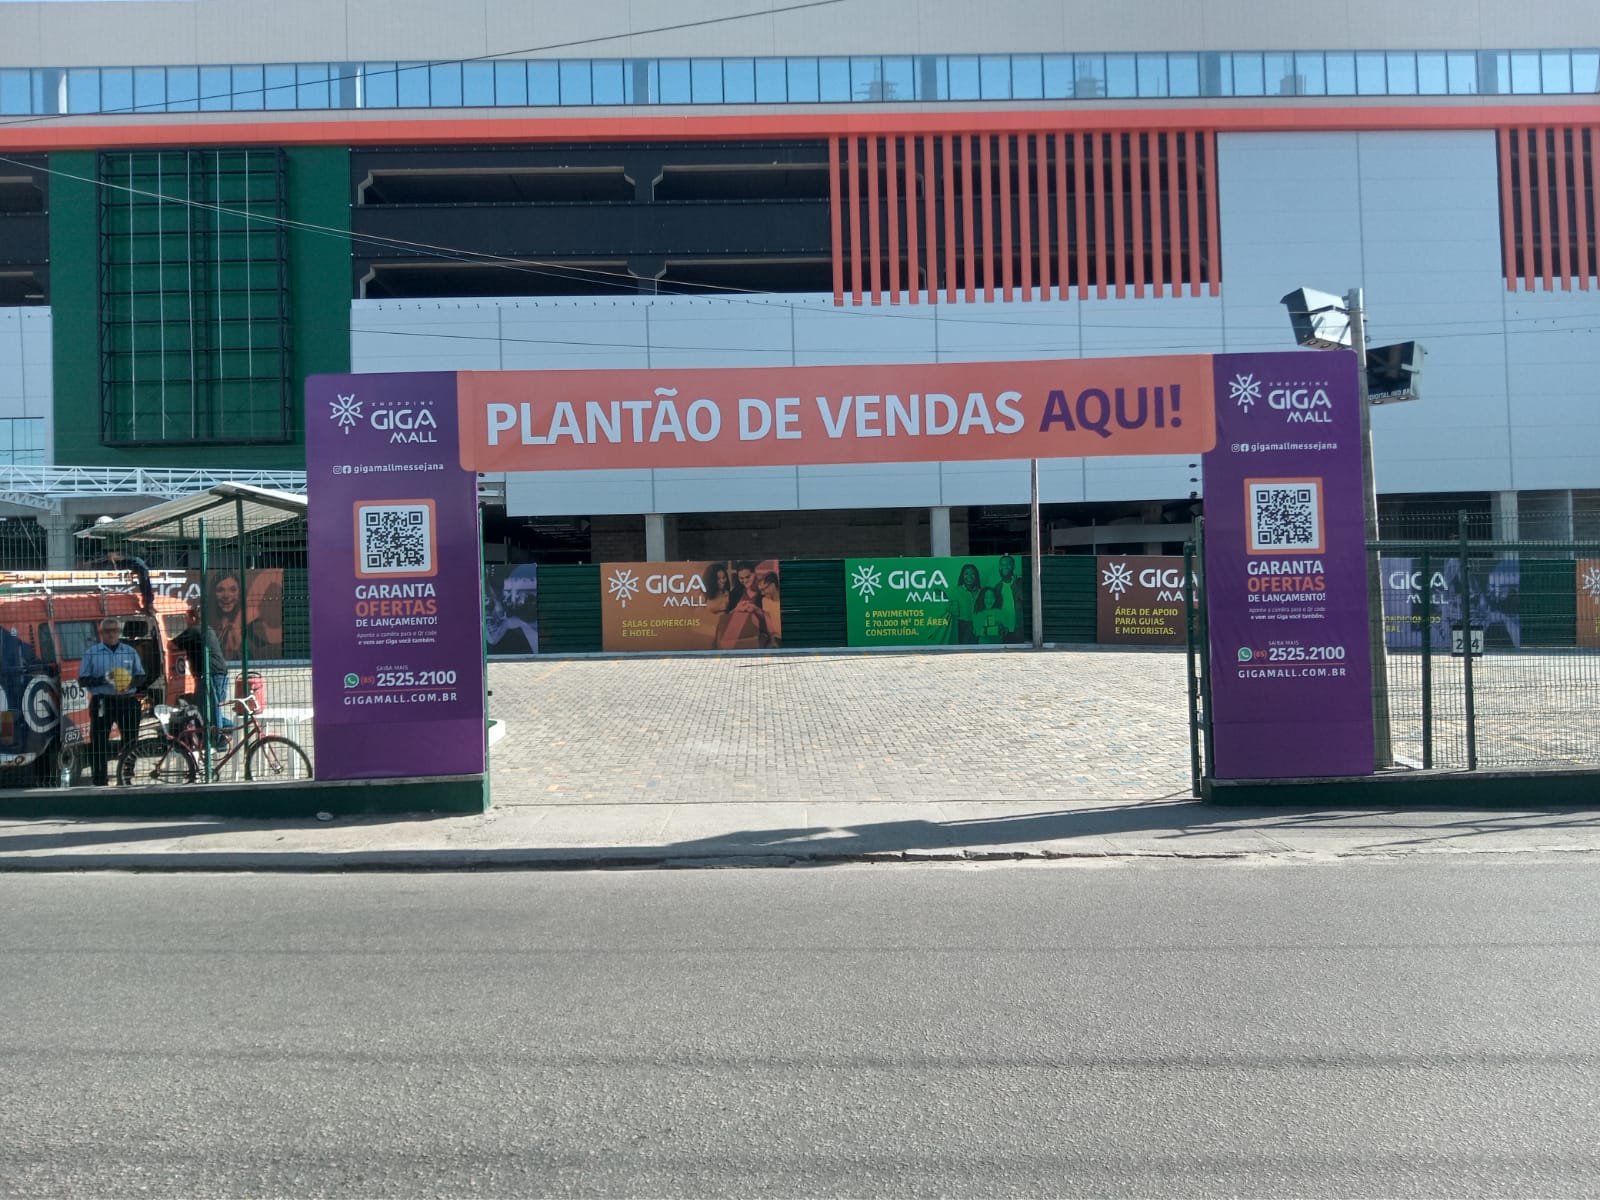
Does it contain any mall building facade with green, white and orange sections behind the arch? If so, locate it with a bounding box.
[0,0,1600,562]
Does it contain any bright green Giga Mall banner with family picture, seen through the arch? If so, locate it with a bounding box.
[845,554,1032,646]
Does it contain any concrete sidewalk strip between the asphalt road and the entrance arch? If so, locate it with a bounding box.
[0,800,1600,872]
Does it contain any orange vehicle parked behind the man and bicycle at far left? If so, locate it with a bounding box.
[0,571,192,787]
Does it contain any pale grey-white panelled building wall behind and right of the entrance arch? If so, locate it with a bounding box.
[352,131,1600,515]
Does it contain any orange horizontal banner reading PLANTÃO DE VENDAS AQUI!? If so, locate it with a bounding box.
[456,354,1216,470]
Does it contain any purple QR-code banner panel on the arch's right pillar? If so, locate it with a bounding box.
[1203,350,1373,779]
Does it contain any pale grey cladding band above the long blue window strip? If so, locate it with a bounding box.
[12,0,1600,66]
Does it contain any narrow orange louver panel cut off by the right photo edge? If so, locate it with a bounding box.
[1499,125,1600,291]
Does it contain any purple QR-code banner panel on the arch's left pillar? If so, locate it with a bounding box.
[306,373,485,779]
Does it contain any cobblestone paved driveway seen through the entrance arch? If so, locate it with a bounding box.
[490,651,1189,805]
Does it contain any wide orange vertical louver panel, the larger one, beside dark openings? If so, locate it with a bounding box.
[829,130,1216,304]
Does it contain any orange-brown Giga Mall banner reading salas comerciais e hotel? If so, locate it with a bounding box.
[600,558,782,651]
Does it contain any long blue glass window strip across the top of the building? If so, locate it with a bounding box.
[9,50,1600,117]
